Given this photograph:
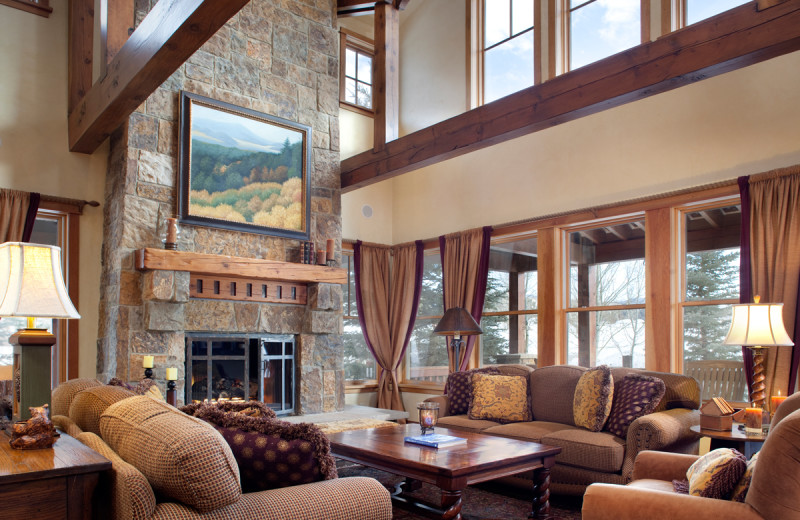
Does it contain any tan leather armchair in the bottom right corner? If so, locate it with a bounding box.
[582,392,800,520]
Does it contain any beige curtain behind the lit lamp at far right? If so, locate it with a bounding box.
[750,167,800,396]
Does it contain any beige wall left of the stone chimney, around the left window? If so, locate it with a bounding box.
[0,0,107,377]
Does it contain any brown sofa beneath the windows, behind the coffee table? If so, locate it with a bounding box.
[427,365,700,494]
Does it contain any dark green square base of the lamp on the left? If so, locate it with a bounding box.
[8,328,56,421]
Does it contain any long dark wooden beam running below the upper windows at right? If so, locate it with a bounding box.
[341,0,800,192]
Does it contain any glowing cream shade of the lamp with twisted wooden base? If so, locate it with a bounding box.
[724,303,794,347]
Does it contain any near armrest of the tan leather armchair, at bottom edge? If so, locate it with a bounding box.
[581,484,764,520]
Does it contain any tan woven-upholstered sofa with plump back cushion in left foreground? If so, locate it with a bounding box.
[52,379,392,520]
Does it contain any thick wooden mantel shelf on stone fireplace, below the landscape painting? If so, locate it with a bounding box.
[136,247,347,284]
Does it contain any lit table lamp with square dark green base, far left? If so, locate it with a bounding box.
[0,242,80,421]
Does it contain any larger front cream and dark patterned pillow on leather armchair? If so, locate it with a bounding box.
[686,448,747,499]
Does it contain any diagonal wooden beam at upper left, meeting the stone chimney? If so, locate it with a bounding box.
[69,0,248,153]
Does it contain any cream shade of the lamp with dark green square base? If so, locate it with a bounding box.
[0,242,81,318]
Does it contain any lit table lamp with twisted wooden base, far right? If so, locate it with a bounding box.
[724,296,794,409]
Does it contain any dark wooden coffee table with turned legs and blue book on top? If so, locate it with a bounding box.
[328,424,561,520]
